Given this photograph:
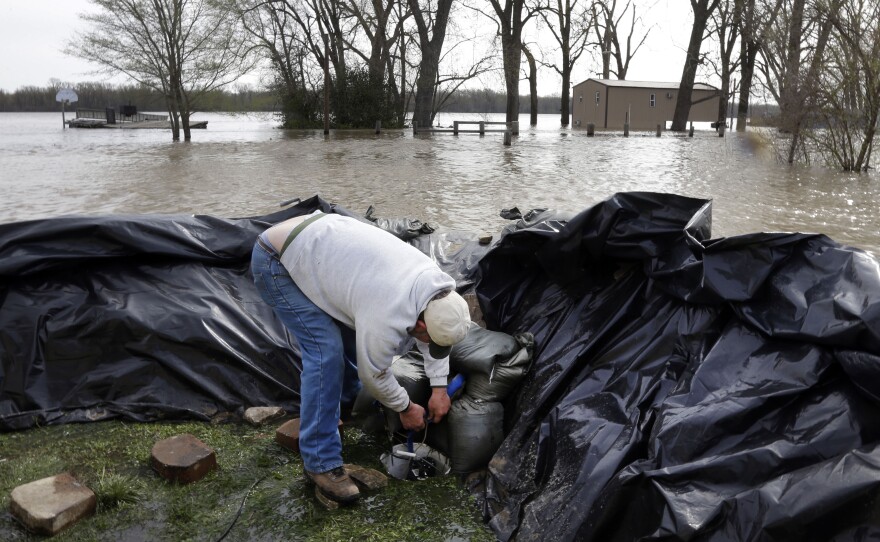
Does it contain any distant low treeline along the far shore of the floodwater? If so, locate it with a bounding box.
[0,83,560,114]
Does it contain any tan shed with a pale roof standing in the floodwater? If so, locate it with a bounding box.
[572,79,721,130]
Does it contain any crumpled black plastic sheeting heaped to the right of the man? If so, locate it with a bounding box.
[477,193,880,541]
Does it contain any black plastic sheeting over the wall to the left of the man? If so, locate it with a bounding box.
[0,197,486,430]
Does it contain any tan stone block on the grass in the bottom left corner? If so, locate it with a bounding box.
[9,473,98,535]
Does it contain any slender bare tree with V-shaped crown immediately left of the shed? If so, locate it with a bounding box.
[540,0,592,126]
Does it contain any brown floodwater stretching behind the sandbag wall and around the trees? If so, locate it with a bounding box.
[0,112,880,255]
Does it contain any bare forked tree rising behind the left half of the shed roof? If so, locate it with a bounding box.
[590,0,651,80]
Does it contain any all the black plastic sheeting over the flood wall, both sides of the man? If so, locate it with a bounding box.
[0,193,880,541]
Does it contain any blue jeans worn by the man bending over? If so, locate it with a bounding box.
[251,244,361,472]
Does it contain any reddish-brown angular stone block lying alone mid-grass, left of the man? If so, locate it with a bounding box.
[151,434,217,484]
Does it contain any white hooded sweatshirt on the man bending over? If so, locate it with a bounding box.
[281,214,455,412]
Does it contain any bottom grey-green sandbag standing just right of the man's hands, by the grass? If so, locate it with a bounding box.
[447,395,504,474]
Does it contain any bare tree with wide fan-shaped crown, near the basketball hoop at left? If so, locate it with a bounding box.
[66,0,252,141]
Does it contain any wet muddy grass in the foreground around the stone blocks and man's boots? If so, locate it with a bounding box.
[0,421,495,542]
